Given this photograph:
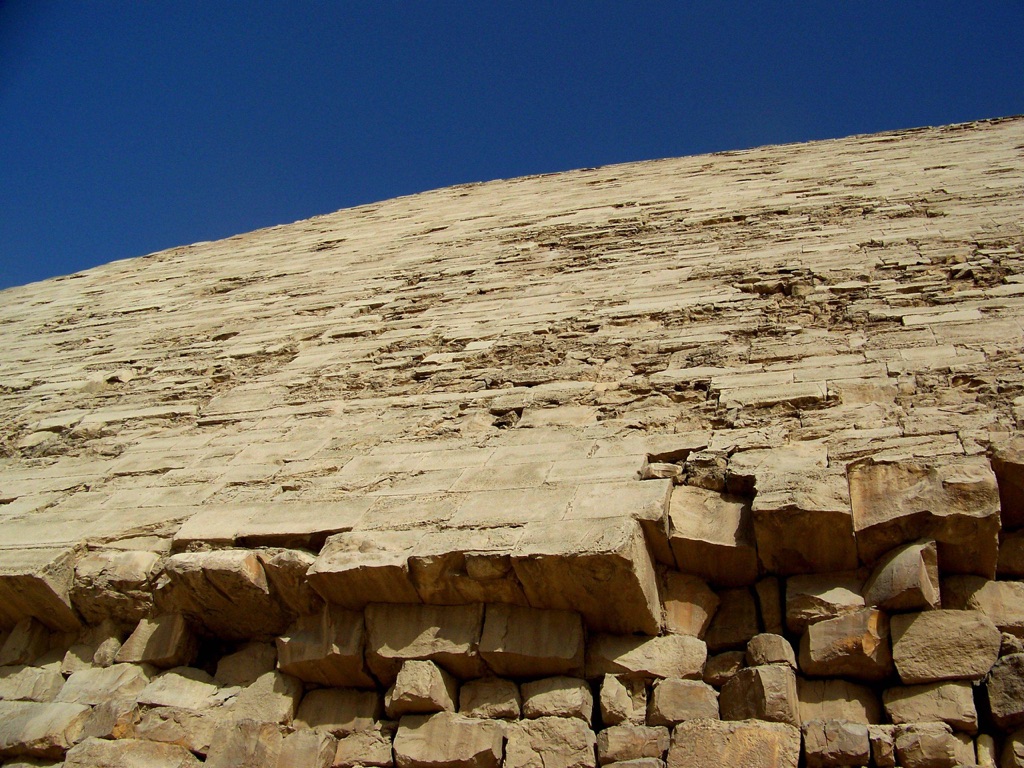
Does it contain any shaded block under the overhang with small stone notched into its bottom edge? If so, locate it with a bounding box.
[365,603,484,685]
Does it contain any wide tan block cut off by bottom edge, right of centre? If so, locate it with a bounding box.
[668,720,800,768]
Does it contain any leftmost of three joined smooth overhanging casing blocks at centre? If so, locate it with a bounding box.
[307,530,423,610]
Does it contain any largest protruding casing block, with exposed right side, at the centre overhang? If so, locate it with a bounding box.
[512,518,662,635]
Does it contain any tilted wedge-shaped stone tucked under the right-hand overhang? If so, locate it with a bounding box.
[864,541,942,611]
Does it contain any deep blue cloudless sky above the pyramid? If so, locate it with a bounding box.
[0,0,1024,290]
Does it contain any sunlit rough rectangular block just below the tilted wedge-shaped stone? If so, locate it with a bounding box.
[891,610,1000,685]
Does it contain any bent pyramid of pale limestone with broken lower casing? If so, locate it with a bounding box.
[0,118,1024,768]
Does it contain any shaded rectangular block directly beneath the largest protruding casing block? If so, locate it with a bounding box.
[480,604,584,677]
